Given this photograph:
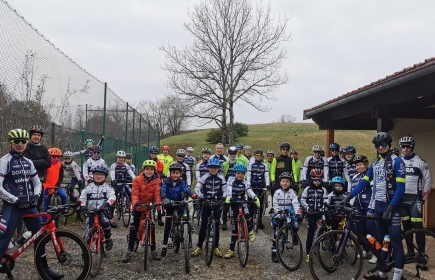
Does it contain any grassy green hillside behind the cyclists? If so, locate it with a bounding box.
[160,123,376,161]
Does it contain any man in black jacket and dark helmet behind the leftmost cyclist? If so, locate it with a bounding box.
[23,125,51,209]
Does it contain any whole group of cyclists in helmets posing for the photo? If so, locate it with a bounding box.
[0,126,432,280]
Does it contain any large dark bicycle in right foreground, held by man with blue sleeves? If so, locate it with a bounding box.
[309,207,435,279]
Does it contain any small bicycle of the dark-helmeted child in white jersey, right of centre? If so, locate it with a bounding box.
[275,209,304,271]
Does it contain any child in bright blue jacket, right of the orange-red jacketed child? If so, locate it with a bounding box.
[160,162,196,257]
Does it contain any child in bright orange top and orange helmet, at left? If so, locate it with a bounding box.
[41,148,66,222]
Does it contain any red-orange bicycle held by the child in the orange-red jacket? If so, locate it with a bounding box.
[127,203,162,270]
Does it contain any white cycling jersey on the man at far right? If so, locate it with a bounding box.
[402,153,432,200]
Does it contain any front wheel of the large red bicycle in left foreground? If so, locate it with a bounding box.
[35,230,92,280]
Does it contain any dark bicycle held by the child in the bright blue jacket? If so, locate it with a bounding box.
[168,200,193,273]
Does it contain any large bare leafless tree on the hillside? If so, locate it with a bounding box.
[160,0,290,144]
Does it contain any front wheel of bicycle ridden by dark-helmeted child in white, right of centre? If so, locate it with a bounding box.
[276,225,303,271]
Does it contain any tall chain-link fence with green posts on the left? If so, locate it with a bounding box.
[0,0,160,166]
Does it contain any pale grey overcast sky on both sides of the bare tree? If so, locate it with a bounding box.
[8,0,435,127]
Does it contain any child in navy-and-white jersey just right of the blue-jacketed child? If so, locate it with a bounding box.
[191,158,227,258]
